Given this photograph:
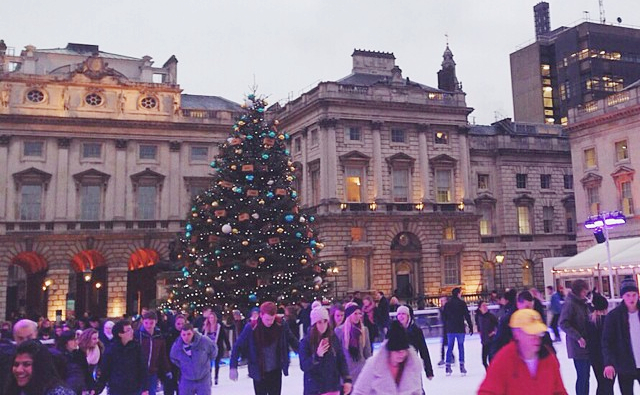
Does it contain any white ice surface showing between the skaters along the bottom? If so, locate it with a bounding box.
[212,334,640,395]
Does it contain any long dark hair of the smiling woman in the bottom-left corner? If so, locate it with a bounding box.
[5,340,63,395]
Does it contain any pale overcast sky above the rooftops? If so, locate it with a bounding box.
[0,0,640,124]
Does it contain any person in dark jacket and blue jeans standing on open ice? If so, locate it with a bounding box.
[443,287,473,376]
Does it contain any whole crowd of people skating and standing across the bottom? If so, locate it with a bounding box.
[0,279,640,395]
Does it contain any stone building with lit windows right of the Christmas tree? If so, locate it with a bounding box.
[275,47,575,297]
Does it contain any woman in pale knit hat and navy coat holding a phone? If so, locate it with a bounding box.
[299,306,352,395]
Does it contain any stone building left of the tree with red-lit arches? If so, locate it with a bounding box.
[0,44,240,318]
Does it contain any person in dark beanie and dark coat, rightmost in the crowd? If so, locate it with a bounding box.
[602,278,640,395]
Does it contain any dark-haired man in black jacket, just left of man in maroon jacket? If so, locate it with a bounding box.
[95,320,149,395]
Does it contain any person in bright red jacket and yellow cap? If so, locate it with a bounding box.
[478,309,568,395]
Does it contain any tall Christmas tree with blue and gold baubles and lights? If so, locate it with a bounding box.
[167,94,328,310]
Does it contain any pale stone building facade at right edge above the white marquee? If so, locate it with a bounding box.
[566,82,640,251]
